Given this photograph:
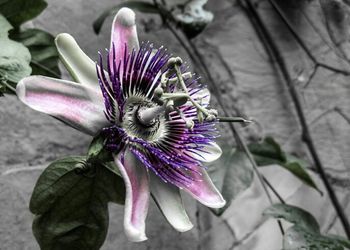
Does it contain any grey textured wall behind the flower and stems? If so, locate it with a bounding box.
[0,0,350,250]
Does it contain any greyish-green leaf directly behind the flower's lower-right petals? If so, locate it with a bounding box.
[208,149,253,216]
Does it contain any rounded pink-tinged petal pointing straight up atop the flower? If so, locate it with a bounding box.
[110,7,139,65]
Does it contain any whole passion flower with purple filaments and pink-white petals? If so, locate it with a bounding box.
[17,8,225,241]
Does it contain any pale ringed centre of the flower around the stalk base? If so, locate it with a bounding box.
[121,96,165,142]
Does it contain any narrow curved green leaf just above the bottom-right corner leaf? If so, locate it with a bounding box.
[264,204,320,233]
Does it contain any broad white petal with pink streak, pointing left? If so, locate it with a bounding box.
[16,76,109,135]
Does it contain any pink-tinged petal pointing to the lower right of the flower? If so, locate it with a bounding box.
[178,166,226,208]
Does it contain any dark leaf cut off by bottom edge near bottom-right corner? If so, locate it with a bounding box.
[283,226,344,250]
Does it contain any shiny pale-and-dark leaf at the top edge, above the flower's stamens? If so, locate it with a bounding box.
[175,0,214,38]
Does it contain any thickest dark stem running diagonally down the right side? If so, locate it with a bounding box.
[239,0,350,239]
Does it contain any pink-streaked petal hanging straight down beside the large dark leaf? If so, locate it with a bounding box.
[114,148,150,242]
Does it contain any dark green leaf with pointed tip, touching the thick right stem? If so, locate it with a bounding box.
[248,137,322,194]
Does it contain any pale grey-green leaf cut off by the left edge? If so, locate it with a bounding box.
[0,15,32,93]
